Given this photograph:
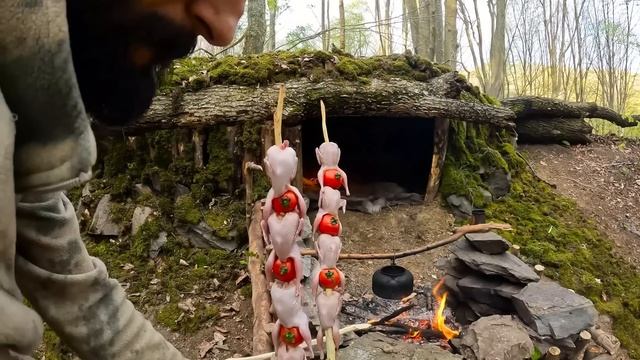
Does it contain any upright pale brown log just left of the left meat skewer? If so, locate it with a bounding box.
[248,202,273,354]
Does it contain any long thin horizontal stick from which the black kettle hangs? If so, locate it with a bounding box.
[302,223,512,260]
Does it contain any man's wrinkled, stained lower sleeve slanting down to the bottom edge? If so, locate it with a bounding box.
[16,193,184,360]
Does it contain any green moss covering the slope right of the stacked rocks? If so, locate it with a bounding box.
[487,171,640,358]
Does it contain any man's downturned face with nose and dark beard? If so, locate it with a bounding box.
[67,0,245,125]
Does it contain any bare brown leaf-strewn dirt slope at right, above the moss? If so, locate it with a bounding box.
[520,138,640,266]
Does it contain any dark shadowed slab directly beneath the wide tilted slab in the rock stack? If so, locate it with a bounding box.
[457,275,524,309]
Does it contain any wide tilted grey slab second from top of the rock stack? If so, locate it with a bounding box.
[449,240,540,283]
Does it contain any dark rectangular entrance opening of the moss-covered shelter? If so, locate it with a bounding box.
[302,117,435,195]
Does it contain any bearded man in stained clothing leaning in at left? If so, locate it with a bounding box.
[0,0,244,360]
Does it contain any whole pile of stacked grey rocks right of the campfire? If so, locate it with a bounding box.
[439,232,598,359]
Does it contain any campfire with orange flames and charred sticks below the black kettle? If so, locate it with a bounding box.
[342,281,459,349]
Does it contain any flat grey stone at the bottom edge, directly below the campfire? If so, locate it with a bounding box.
[337,332,462,360]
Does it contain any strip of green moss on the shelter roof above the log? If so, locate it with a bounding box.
[160,49,451,96]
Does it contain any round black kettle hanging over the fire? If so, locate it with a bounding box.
[371,262,413,300]
